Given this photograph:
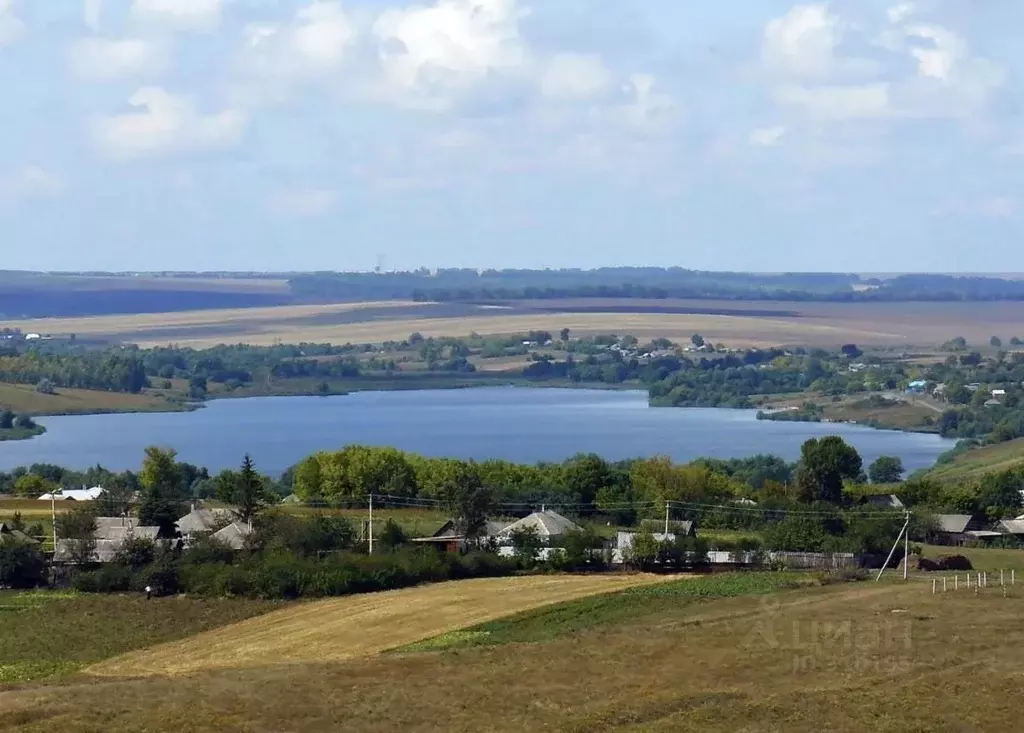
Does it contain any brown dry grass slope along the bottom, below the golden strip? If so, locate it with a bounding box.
[6,581,1024,733]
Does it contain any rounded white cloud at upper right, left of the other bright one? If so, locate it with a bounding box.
[761,3,842,77]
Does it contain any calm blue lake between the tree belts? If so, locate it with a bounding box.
[0,387,953,474]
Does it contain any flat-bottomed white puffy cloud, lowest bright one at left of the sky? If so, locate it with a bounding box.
[92,87,246,159]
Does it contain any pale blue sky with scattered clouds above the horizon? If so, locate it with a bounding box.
[0,0,1024,272]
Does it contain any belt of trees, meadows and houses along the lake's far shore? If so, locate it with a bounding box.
[0,329,1024,464]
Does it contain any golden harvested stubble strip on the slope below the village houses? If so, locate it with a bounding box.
[86,574,664,677]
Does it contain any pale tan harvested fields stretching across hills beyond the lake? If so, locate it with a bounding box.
[6,299,1024,347]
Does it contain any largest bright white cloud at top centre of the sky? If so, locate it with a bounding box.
[373,0,527,106]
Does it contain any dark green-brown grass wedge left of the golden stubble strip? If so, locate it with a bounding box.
[0,591,282,687]
